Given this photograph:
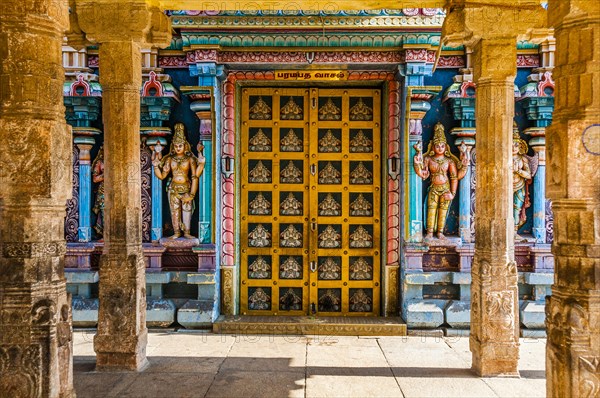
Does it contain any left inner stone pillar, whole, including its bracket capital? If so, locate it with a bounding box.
[71,0,170,370]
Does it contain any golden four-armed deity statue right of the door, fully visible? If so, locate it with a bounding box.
[413,123,469,240]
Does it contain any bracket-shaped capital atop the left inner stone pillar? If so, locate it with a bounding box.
[67,0,171,48]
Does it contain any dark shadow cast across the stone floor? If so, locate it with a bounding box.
[74,356,545,398]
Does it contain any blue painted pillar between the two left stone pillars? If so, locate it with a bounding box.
[63,74,102,242]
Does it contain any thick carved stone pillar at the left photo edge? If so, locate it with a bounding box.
[0,0,74,397]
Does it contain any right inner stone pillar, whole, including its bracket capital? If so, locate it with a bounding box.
[442,0,544,376]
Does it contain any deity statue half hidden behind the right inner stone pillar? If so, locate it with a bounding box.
[512,124,538,236]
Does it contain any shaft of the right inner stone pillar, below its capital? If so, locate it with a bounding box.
[470,38,519,376]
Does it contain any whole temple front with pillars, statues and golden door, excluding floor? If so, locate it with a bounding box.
[0,0,600,397]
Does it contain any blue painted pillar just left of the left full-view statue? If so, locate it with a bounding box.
[140,71,181,242]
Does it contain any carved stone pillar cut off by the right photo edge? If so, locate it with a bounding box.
[546,0,600,397]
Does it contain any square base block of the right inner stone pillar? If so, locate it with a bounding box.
[469,337,520,377]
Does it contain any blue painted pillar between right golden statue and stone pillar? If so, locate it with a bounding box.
[442,77,475,243]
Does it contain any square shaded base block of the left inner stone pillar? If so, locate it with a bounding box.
[94,330,149,372]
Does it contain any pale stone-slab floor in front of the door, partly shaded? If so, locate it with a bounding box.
[74,332,546,398]
